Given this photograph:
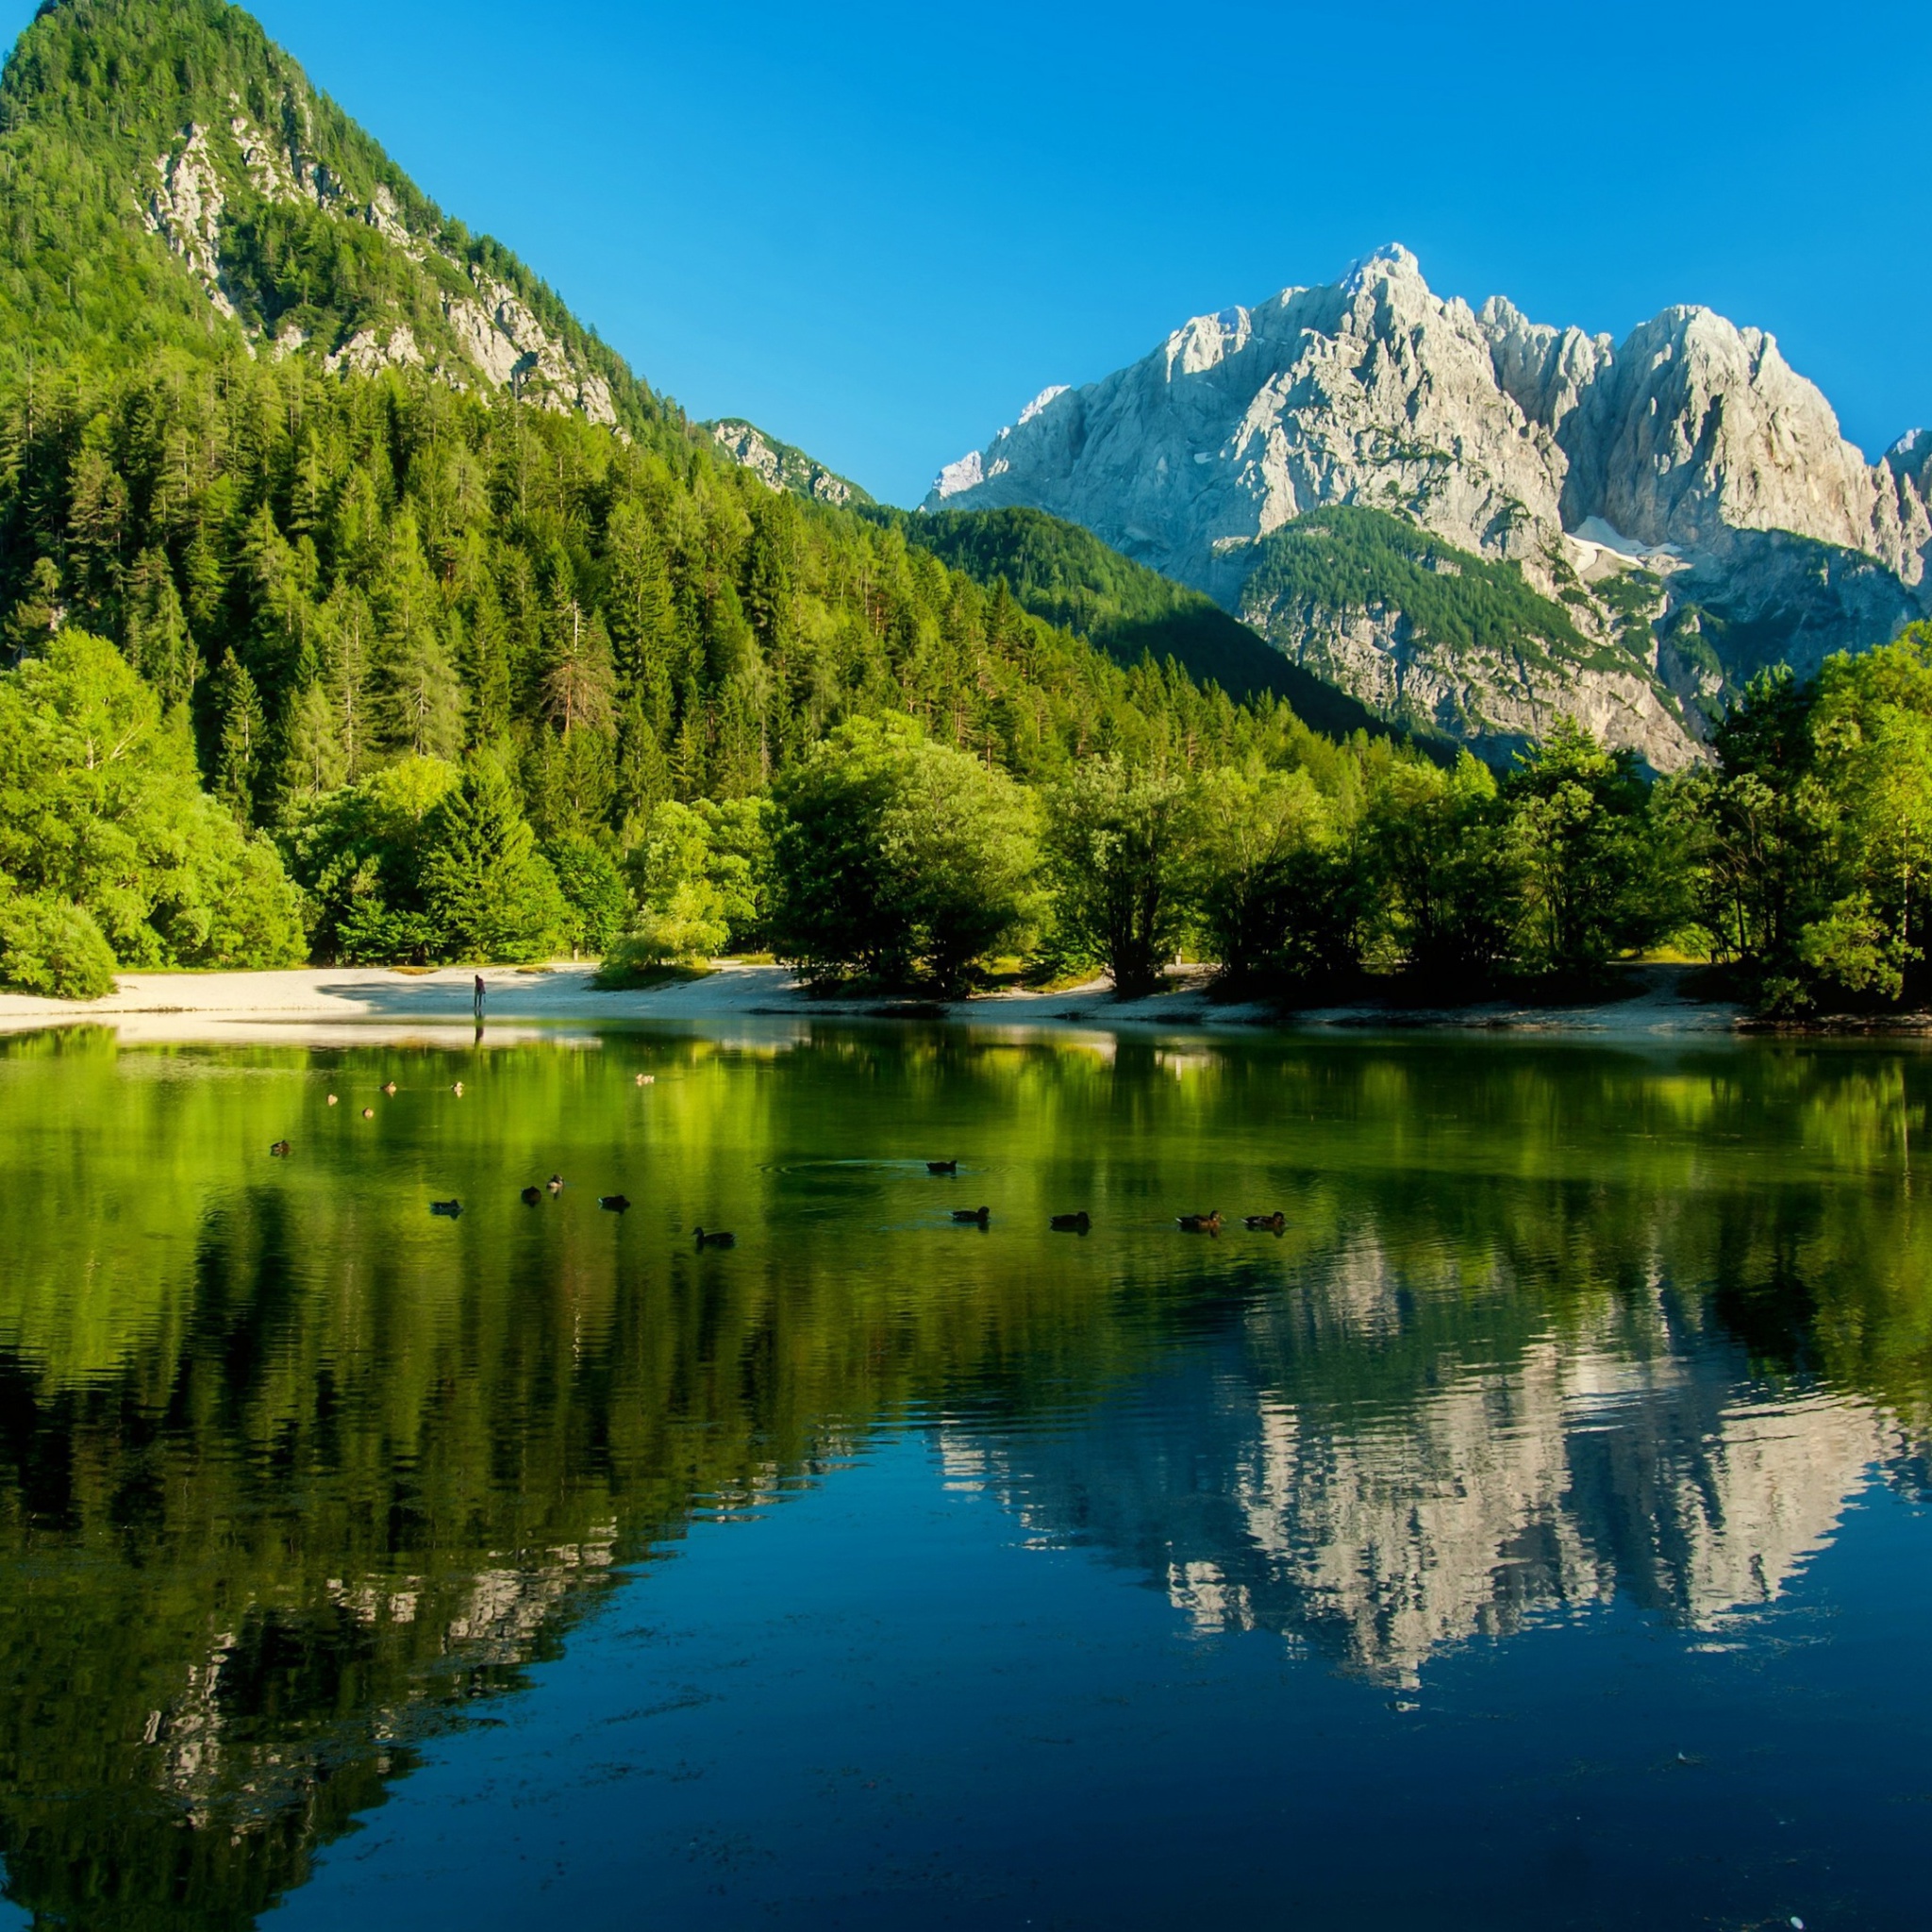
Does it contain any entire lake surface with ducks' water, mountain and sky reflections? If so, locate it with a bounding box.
[0,1022,1932,1932]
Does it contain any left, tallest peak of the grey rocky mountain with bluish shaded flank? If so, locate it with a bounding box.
[946,249,1561,595]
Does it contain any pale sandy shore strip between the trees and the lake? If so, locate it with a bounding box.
[0,960,1740,1041]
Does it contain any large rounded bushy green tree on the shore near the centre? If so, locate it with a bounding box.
[771,719,1038,991]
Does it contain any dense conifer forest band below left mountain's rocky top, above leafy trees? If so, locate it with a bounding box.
[0,359,1320,846]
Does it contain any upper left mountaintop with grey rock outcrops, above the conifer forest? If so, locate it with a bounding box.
[0,0,662,431]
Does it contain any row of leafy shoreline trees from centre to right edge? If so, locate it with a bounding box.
[618,625,1932,1014]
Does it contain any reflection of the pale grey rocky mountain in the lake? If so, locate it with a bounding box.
[944,1256,1907,1685]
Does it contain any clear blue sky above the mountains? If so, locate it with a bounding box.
[0,0,1932,502]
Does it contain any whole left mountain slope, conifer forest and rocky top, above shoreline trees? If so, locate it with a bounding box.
[0,0,1329,935]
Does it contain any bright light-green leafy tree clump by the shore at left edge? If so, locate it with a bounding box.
[0,630,301,979]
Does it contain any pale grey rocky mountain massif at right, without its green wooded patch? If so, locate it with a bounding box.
[925,247,1932,769]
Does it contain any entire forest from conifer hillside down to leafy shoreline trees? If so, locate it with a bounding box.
[0,356,1932,1010]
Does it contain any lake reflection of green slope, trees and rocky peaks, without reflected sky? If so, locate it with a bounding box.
[0,1025,1932,1926]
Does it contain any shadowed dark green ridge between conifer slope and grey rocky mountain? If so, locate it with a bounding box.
[885,508,1390,736]
